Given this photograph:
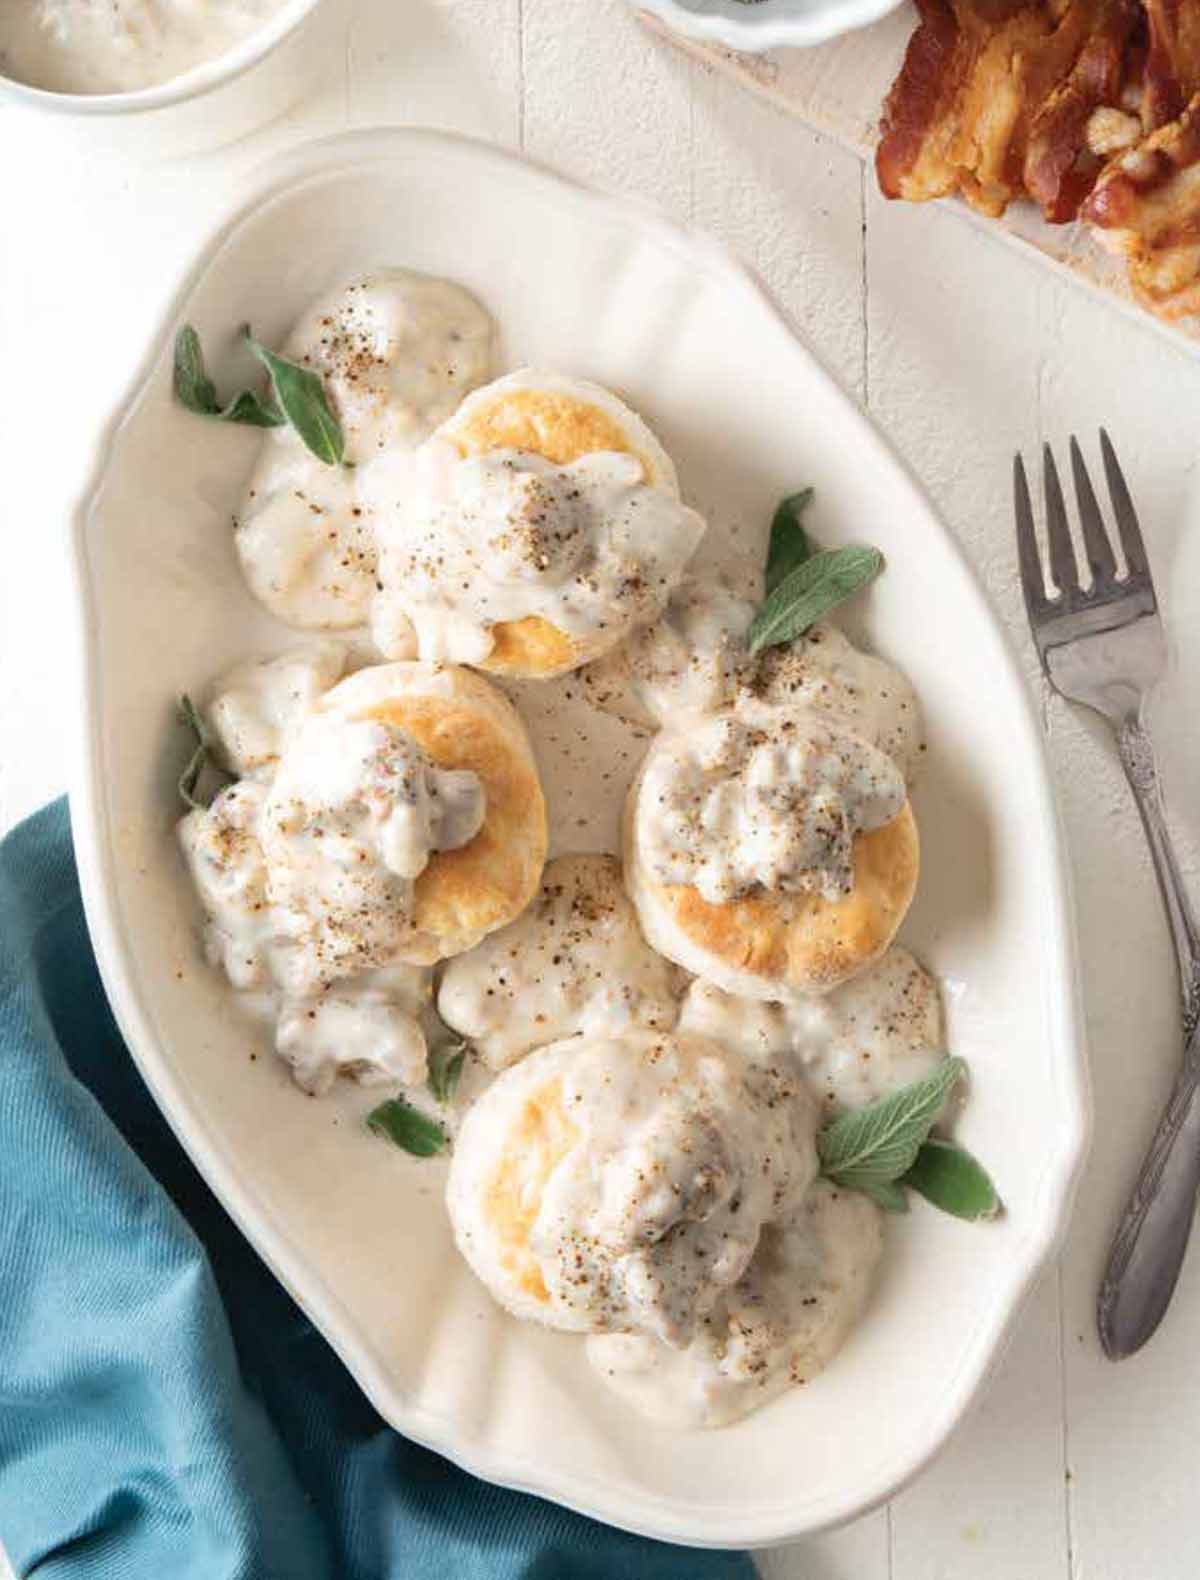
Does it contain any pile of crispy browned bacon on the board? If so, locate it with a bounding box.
[876,0,1200,316]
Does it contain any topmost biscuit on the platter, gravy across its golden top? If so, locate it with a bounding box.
[364,368,704,678]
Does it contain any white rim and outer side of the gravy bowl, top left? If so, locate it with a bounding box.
[0,0,321,153]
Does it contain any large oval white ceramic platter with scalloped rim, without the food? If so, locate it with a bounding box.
[65,130,1086,1545]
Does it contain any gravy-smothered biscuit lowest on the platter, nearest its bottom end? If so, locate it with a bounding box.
[446,1030,817,1346]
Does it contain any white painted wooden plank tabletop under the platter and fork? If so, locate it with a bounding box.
[0,0,1200,1580]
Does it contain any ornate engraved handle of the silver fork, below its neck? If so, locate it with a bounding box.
[1097,716,1200,1360]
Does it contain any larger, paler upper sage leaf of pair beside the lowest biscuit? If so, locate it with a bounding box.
[817,1059,966,1190]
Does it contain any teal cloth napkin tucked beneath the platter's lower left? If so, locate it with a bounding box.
[0,801,754,1580]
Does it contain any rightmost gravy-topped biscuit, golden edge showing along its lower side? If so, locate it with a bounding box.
[625,705,919,1000]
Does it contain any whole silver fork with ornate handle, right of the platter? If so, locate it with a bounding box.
[1013,430,1200,1360]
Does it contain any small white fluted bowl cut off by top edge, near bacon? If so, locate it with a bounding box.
[634,0,901,55]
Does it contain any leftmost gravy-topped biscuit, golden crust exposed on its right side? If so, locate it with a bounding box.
[273,662,547,969]
